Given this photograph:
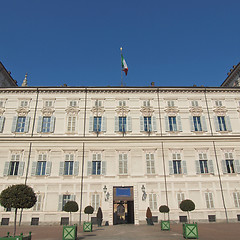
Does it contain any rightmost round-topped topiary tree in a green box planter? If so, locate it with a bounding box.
[180,199,198,239]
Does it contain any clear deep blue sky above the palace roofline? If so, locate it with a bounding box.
[0,0,240,86]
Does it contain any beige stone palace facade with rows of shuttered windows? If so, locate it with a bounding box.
[0,86,240,224]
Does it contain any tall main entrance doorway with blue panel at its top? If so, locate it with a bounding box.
[113,187,134,225]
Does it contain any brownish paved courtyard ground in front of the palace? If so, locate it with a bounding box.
[0,223,240,240]
